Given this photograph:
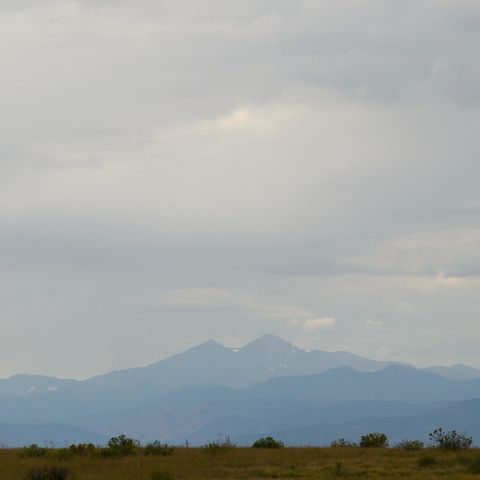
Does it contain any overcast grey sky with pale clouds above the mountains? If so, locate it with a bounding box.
[0,0,480,378]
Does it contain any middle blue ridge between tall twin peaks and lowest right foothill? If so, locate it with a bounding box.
[82,366,480,443]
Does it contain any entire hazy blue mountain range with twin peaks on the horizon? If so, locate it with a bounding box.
[0,335,480,445]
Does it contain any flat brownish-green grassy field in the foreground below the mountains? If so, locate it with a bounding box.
[0,448,480,480]
